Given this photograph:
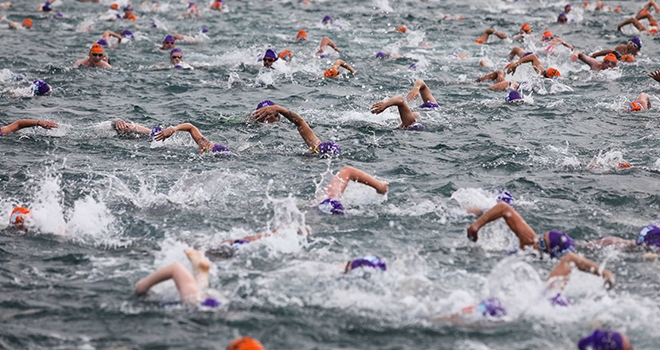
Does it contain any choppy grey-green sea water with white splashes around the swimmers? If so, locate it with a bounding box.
[0,0,660,350]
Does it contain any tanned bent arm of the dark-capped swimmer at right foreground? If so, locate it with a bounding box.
[467,202,538,249]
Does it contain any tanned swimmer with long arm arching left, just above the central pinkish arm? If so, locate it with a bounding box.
[252,100,341,156]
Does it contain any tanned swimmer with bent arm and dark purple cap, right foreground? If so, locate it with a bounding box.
[467,202,575,258]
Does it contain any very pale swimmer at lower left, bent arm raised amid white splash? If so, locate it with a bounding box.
[135,249,222,307]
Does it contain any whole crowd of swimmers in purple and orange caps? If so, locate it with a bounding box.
[5,0,660,350]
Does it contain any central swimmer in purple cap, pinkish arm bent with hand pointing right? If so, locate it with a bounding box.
[317,166,390,215]
